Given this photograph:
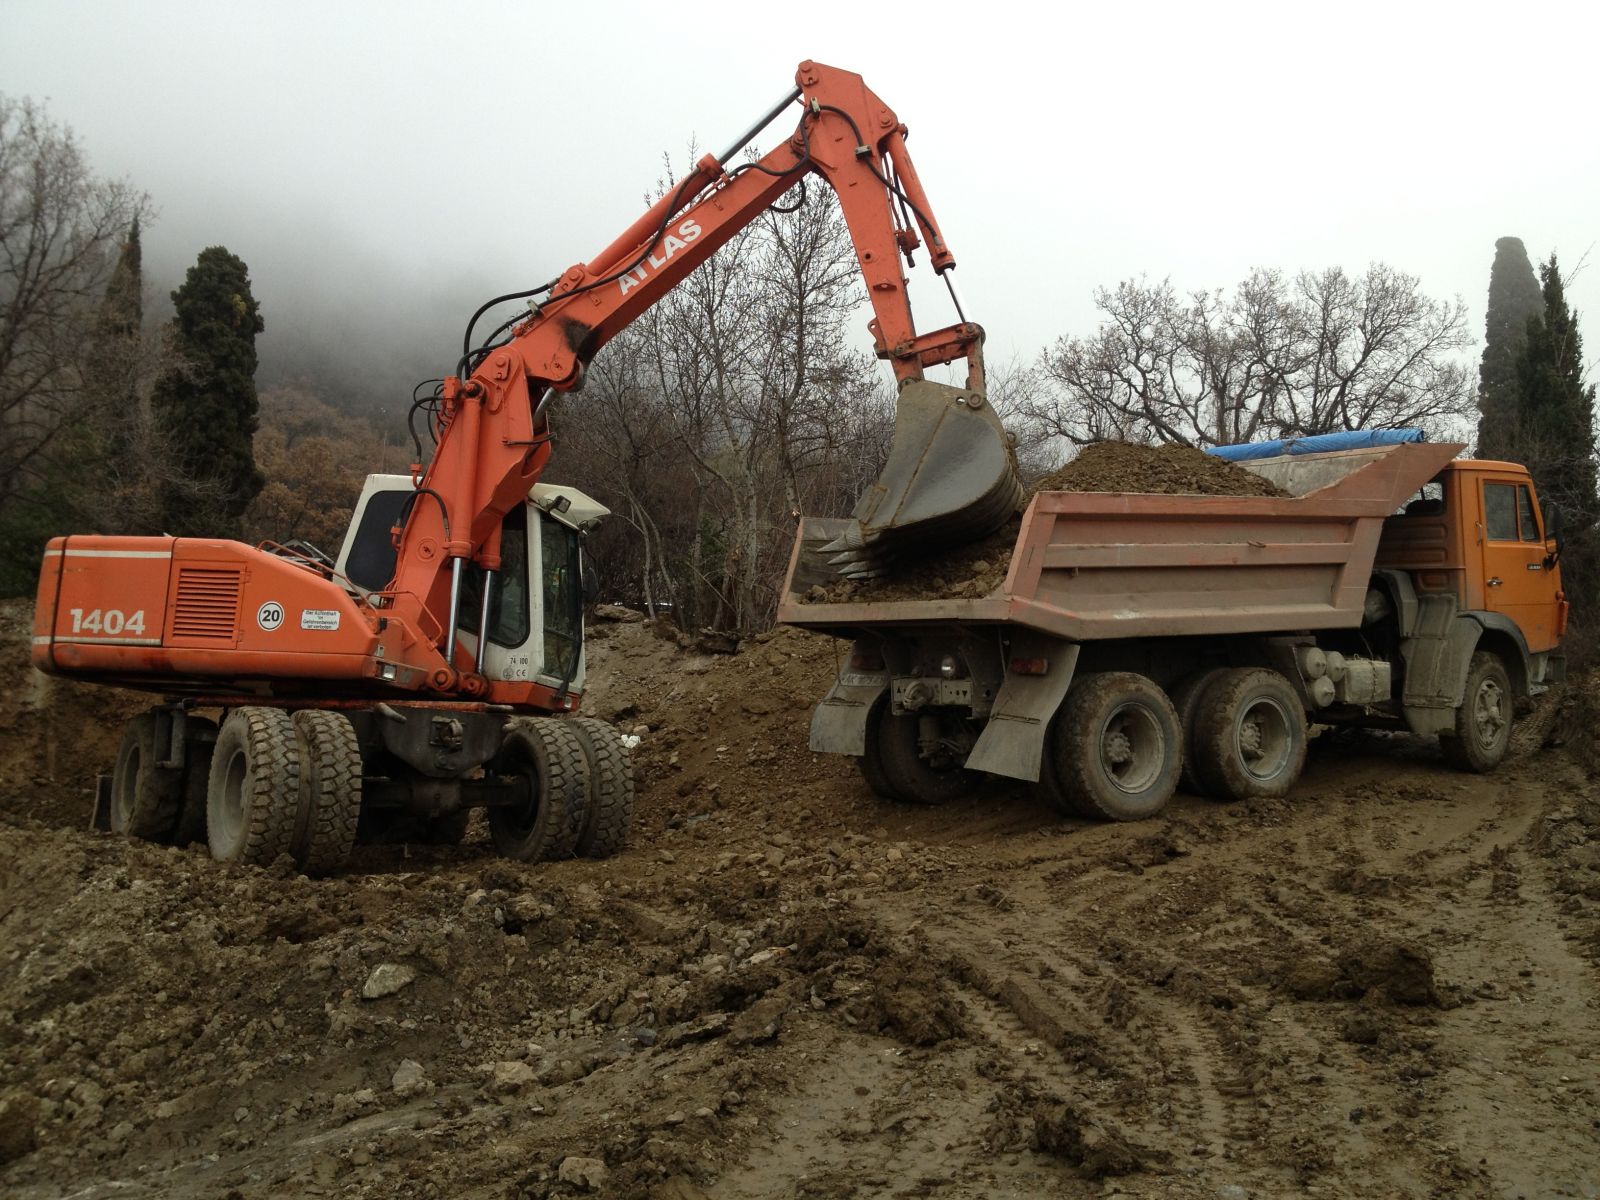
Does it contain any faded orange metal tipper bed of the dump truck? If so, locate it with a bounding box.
[778,443,1462,642]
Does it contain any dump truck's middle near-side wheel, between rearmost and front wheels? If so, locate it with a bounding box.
[1194,667,1306,800]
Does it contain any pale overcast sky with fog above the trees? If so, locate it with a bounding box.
[0,0,1600,409]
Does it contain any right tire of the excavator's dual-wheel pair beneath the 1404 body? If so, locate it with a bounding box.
[290,709,362,875]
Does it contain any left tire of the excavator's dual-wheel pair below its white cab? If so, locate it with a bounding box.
[490,718,587,862]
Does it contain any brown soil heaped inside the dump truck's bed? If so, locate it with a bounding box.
[800,442,1286,605]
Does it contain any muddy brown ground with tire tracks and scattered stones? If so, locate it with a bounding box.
[0,606,1600,1200]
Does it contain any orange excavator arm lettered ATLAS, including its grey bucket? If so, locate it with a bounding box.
[373,61,1021,691]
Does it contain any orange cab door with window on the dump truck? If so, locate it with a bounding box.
[1478,475,1558,653]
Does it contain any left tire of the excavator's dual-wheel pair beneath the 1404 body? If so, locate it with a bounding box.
[205,707,301,866]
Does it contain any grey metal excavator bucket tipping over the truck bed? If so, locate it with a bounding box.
[822,379,1022,579]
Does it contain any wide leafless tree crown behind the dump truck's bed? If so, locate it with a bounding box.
[1026,264,1472,446]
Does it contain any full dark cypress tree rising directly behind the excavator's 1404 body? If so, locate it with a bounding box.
[150,246,266,538]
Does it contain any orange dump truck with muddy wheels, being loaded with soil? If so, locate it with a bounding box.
[778,442,1566,819]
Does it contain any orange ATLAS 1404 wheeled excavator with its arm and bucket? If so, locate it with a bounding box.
[32,62,1021,872]
